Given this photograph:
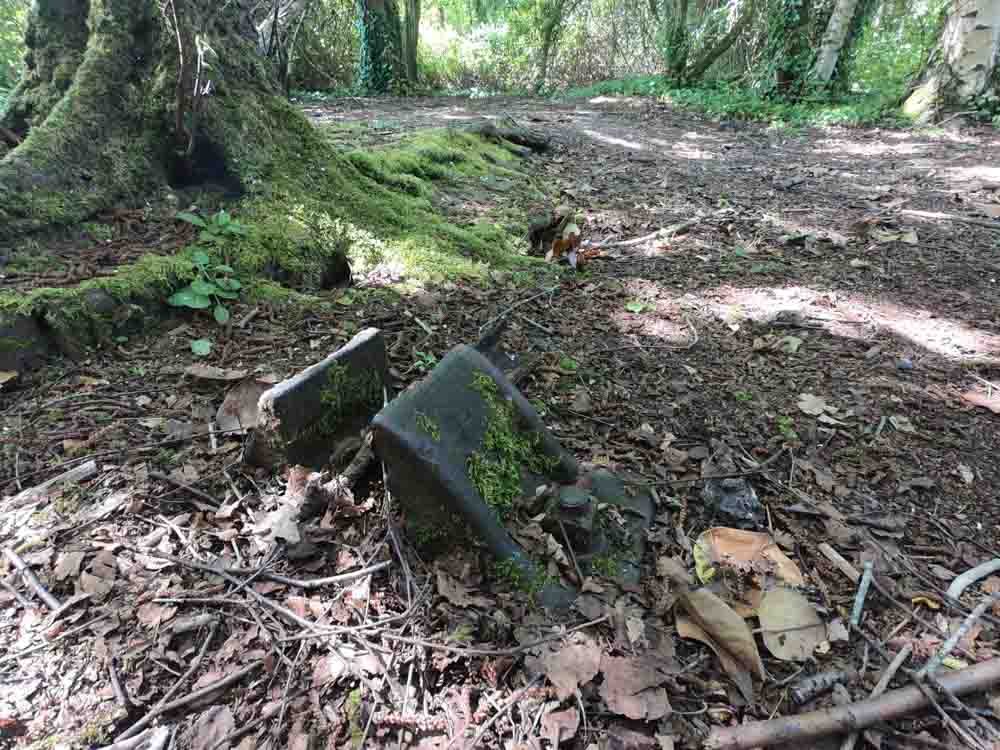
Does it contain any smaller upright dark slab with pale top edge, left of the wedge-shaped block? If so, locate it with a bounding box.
[243,328,387,468]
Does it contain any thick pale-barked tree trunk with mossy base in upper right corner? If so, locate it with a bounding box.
[903,0,1000,122]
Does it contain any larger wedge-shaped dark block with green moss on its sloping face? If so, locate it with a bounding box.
[373,345,578,604]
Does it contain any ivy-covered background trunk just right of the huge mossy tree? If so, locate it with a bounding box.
[358,0,404,94]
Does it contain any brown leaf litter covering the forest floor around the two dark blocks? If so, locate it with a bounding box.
[0,100,1000,748]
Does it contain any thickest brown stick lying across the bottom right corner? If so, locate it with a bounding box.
[704,659,1000,750]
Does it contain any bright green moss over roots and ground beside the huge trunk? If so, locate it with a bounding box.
[0,112,548,356]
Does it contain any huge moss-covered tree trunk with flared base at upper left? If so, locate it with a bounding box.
[0,0,309,239]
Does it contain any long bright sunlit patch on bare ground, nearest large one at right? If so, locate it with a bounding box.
[704,286,1000,363]
